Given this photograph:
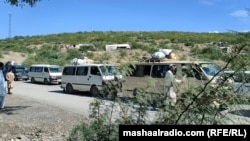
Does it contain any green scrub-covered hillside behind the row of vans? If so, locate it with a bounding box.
[0,31,248,69]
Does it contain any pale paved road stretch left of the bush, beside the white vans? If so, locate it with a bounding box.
[13,81,94,116]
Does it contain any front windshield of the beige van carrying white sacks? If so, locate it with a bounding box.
[200,63,221,76]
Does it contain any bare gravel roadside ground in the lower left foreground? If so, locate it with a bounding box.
[0,94,86,141]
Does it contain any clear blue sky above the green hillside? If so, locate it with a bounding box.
[0,0,250,39]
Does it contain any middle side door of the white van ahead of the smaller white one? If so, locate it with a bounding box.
[74,66,89,91]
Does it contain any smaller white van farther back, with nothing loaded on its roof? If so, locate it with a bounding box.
[28,64,62,85]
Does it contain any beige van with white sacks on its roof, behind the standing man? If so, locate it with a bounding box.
[123,60,225,93]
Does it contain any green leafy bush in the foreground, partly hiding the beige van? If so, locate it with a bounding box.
[69,33,250,141]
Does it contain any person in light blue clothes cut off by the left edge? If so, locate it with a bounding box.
[0,62,7,109]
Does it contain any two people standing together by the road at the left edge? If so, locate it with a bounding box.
[0,61,15,109]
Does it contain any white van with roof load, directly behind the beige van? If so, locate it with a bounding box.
[61,64,122,97]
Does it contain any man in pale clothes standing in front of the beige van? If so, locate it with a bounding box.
[165,64,183,106]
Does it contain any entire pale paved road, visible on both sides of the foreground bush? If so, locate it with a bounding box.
[13,81,250,124]
